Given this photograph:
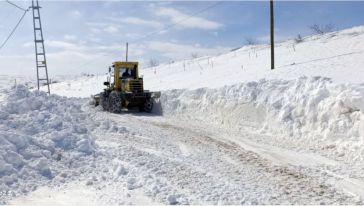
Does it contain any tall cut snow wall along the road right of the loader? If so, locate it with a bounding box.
[161,77,364,161]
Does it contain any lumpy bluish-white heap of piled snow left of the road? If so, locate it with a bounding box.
[0,86,95,203]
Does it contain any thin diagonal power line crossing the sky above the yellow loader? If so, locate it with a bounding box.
[80,1,223,67]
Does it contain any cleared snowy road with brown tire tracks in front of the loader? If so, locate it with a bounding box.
[13,108,364,205]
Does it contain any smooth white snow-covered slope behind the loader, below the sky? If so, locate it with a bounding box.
[45,26,364,97]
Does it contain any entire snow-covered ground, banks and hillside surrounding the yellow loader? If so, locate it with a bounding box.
[0,27,364,205]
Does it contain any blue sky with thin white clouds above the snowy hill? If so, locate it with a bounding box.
[0,1,364,74]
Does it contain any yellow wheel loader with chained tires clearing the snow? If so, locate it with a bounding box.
[94,61,160,113]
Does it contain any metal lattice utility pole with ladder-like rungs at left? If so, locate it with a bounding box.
[32,0,51,94]
